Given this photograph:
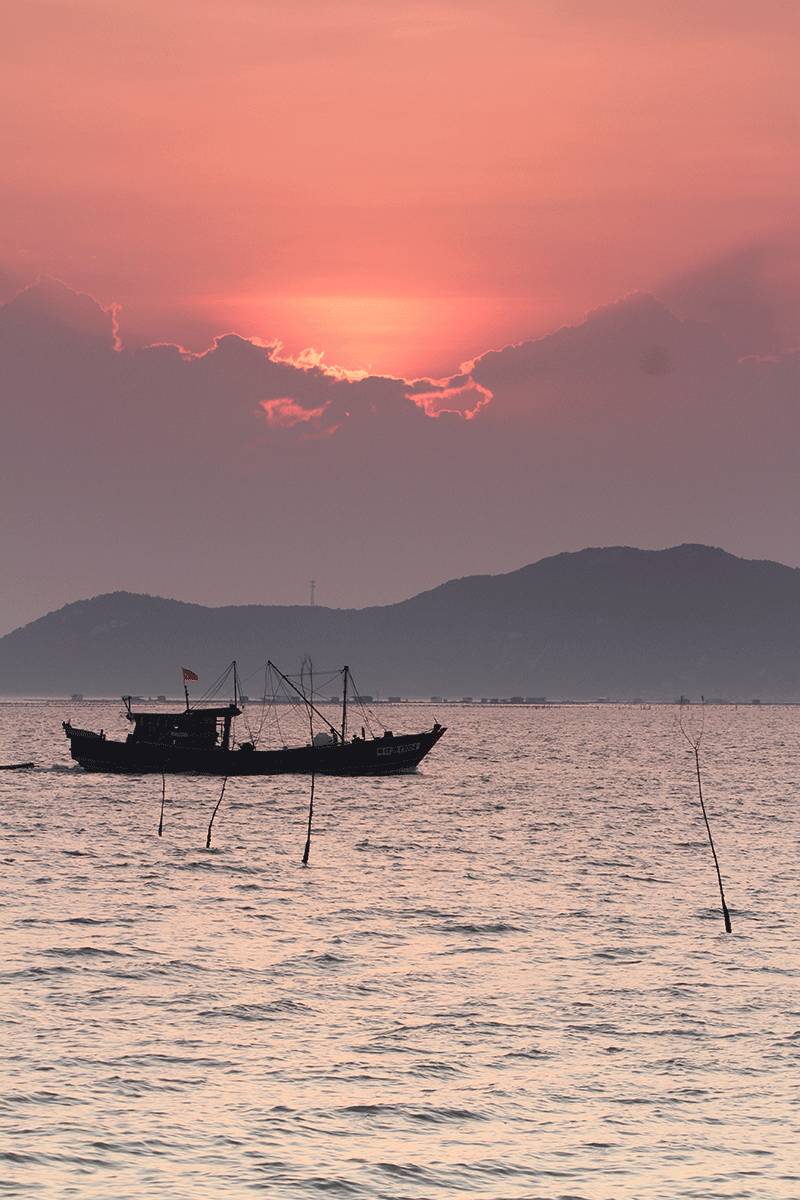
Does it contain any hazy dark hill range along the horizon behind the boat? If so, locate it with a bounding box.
[0,545,800,700]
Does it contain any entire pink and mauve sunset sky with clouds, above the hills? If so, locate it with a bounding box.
[0,0,800,631]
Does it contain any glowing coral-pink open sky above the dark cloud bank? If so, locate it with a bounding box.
[6,0,800,376]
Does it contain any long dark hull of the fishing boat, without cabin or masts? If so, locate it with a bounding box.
[67,726,445,776]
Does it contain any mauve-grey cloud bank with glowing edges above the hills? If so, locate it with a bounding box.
[0,280,800,629]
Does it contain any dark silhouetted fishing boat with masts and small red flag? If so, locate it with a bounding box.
[61,662,445,776]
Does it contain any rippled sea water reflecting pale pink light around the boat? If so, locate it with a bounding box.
[0,702,800,1200]
